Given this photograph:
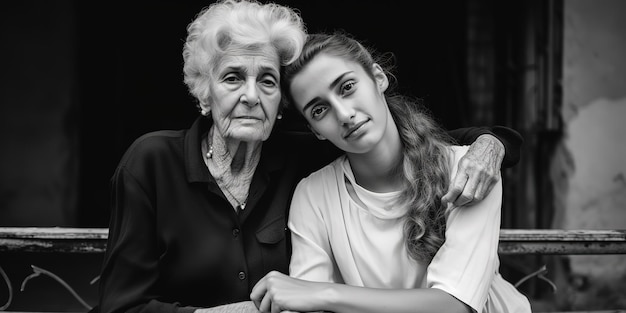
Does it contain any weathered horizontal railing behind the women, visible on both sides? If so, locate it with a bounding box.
[0,227,626,313]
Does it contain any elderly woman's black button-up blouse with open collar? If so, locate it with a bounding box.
[94,117,521,312]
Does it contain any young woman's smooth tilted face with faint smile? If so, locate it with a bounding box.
[290,53,391,153]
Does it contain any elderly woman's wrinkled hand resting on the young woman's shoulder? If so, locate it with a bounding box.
[441,135,505,207]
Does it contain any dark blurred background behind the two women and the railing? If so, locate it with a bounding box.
[0,0,626,311]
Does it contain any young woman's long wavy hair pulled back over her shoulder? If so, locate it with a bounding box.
[281,32,452,262]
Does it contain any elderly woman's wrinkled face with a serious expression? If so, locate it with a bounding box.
[209,49,281,141]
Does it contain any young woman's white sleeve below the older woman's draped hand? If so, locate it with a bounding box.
[427,149,502,312]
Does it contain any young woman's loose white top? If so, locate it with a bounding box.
[288,146,531,312]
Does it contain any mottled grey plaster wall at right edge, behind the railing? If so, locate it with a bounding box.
[552,0,626,305]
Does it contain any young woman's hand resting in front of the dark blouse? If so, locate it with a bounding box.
[250,271,328,313]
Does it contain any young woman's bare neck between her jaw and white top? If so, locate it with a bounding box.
[346,110,403,192]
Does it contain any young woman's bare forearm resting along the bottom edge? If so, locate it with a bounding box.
[321,284,471,313]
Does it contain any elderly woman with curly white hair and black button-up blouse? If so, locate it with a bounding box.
[94,0,518,312]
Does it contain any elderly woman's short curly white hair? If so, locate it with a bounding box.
[183,0,306,103]
